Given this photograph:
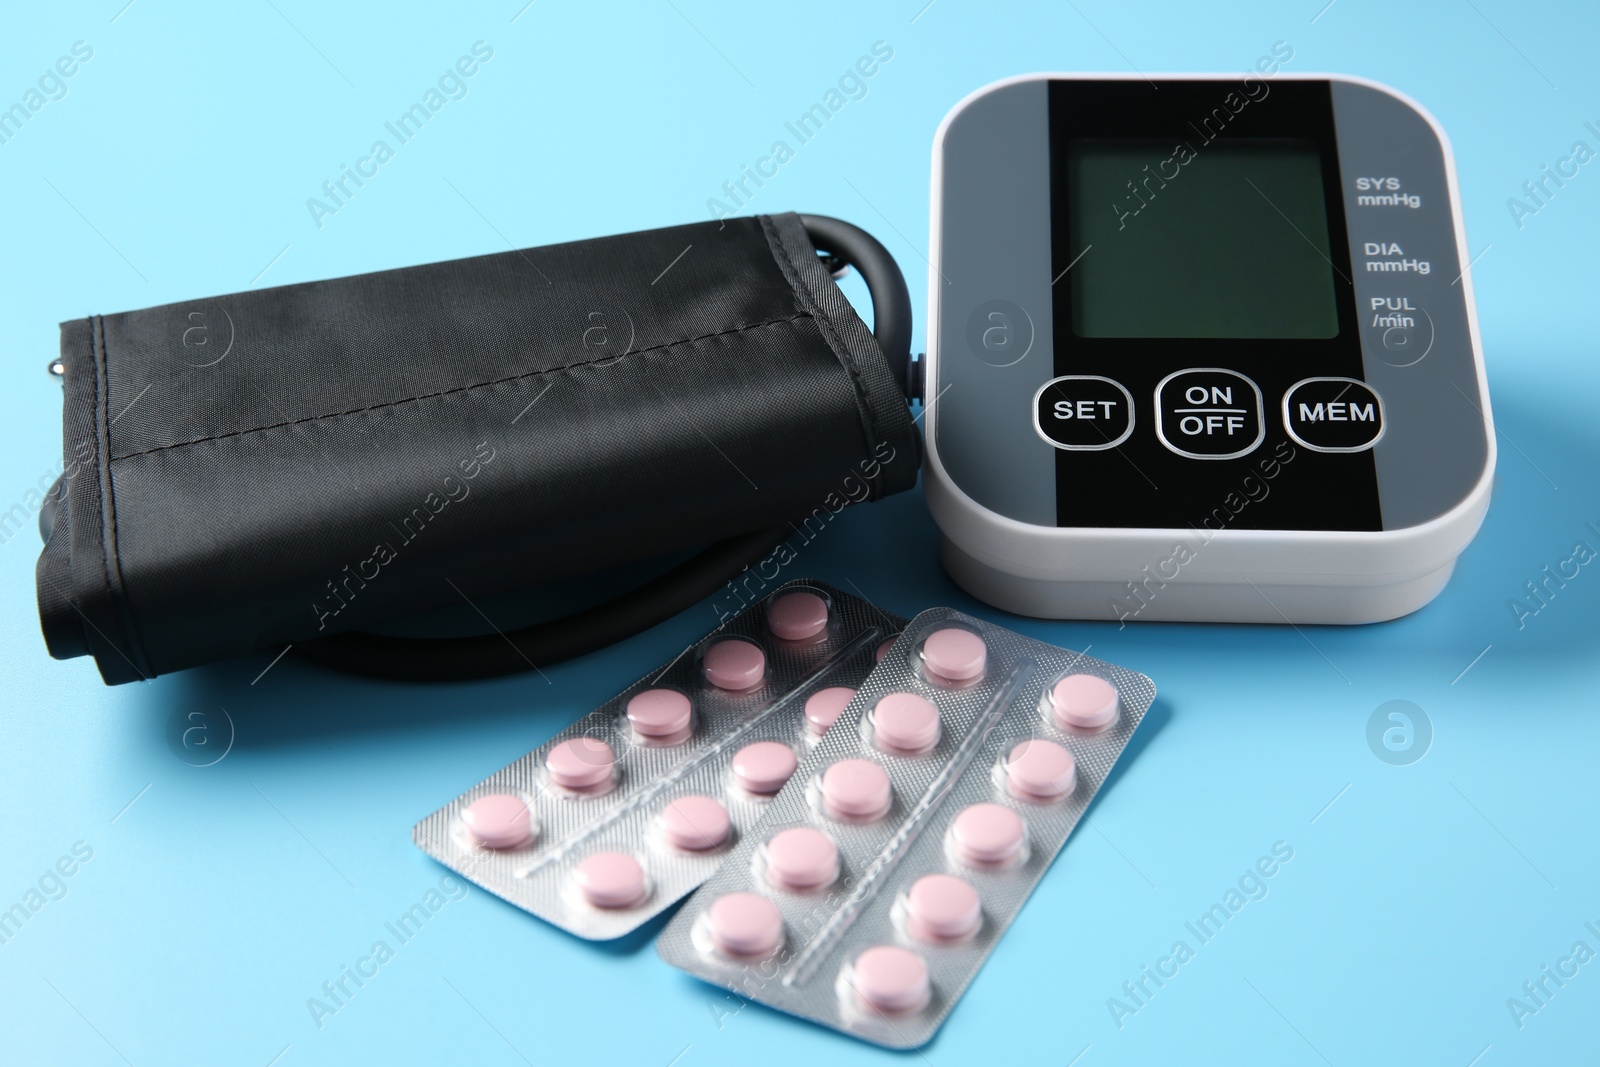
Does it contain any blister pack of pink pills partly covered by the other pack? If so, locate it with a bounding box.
[411,581,906,941]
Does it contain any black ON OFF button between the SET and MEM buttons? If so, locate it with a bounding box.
[1155,366,1267,459]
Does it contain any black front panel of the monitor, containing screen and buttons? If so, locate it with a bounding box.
[1037,80,1382,531]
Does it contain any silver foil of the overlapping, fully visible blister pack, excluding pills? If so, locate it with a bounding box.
[658,608,1155,1048]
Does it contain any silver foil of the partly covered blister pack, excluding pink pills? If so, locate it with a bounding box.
[411,581,906,941]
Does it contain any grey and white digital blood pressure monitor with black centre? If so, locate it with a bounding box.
[923,74,1494,622]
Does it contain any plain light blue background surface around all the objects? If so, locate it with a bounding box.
[0,0,1600,1067]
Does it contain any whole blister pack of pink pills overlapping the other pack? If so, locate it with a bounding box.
[658,608,1155,1048]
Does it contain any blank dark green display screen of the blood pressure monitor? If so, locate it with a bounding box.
[1058,138,1339,339]
